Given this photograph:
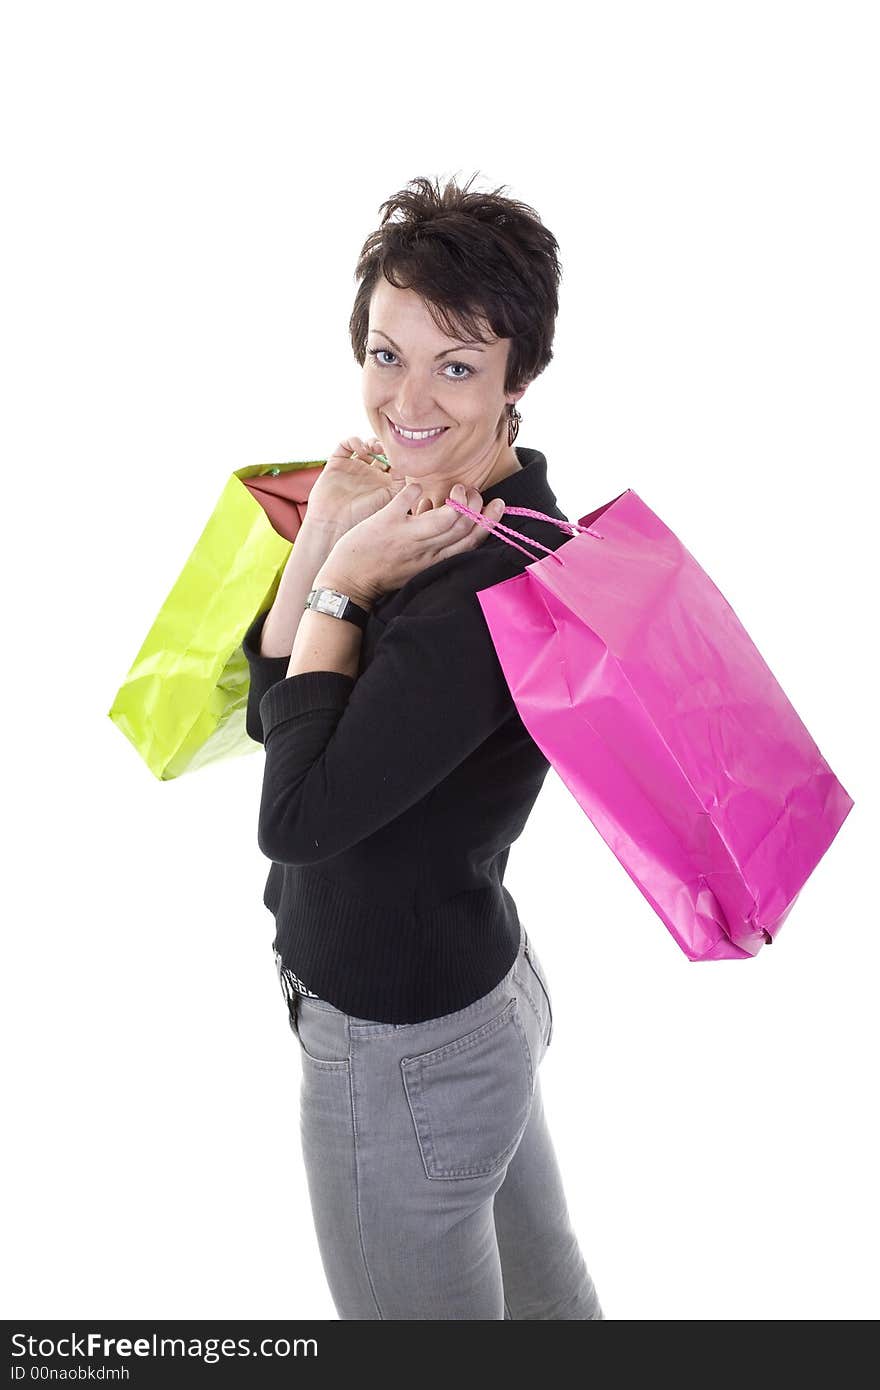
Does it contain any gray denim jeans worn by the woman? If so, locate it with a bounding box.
[275,929,605,1321]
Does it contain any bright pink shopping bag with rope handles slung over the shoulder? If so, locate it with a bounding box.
[455,488,854,960]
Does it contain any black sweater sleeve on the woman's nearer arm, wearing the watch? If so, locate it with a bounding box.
[257,592,514,865]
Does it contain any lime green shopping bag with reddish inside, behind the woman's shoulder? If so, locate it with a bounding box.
[107,459,327,781]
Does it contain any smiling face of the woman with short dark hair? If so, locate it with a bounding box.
[361,277,525,500]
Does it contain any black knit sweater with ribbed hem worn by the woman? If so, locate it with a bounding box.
[243,448,571,1023]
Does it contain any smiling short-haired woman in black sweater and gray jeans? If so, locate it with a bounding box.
[245,179,605,1319]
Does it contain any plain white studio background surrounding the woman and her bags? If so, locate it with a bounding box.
[0,0,880,1319]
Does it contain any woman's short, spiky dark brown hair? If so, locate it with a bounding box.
[349,174,562,391]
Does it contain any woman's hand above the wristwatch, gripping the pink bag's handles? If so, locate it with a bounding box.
[314,482,505,605]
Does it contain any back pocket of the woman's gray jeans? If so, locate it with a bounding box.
[400,997,534,1177]
